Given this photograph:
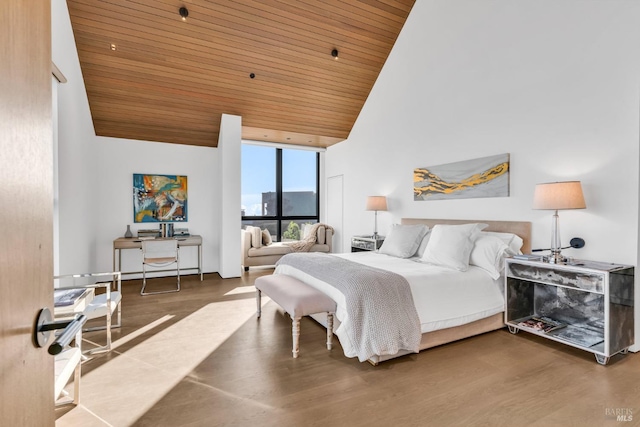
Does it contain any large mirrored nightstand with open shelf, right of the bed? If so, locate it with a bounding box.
[505,258,634,365]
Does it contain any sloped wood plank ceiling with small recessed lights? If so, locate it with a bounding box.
[67,0,414,147]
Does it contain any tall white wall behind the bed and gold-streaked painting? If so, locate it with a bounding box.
[326,0,640,352]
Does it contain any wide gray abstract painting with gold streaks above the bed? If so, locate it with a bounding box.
[413,153,509,200]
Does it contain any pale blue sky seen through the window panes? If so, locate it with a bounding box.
[241,144,316,216]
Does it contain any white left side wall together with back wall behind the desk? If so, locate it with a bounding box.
[52,1,220,274]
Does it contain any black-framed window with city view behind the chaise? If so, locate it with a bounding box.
[241,144,320,241]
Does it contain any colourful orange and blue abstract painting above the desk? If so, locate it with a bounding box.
[133,173,187,222]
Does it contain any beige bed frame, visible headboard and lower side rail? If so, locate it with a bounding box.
[362,218,531,365]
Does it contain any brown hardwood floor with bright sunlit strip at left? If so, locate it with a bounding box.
[56,269,640,427]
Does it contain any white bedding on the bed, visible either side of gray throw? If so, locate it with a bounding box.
[276,252,504,338]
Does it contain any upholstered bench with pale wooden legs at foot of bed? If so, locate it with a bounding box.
[255,274,336,358]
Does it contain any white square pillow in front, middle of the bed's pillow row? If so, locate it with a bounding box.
[420,224,487,271]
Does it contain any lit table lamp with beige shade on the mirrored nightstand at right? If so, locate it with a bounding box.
[533,181,587,264]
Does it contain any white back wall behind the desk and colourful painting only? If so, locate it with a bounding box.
[91,137,218,274]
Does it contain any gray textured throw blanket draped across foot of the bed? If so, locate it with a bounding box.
[277,252,421,362]
